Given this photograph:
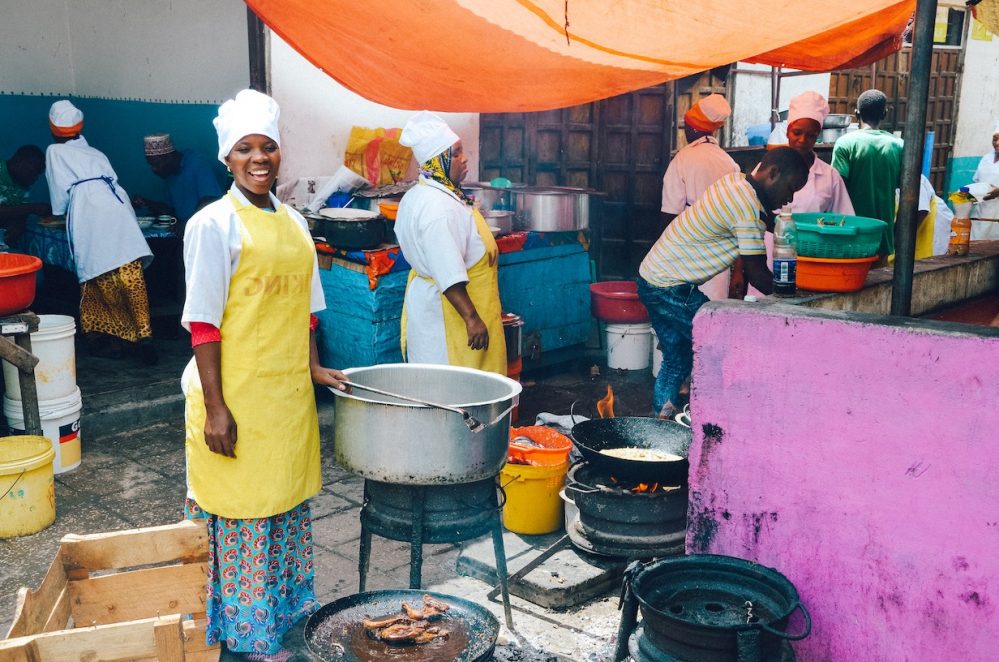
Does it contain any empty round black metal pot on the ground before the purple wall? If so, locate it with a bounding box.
[625,554,812,662]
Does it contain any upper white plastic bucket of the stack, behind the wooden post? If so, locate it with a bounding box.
[3,315,77,402]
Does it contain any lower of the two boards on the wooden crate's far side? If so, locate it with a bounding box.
[69,563,208,627]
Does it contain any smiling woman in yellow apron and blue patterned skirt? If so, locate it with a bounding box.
[182,90,344,662]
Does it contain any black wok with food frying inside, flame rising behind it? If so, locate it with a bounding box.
[572,416,691,485]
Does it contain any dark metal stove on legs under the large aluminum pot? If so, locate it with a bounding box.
[358,478,513,628]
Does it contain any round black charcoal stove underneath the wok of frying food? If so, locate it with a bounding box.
[565,462,687,559]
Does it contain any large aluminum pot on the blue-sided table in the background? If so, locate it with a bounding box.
[513,186,596,232]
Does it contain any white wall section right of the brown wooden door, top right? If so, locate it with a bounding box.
[952,28,999,157]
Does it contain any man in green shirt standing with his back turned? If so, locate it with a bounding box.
[832,90,902,259]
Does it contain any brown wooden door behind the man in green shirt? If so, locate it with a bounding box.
[829,47,964,193]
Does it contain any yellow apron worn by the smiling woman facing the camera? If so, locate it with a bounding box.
[185,194,322,519]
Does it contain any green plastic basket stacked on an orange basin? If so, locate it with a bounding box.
[792,213,888,260]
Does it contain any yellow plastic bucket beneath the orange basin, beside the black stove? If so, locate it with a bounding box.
[500,462,569,535]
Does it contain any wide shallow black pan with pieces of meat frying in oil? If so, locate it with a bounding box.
[304,589,499,662]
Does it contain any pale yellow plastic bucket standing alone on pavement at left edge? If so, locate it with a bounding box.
[0,435,55,538]
